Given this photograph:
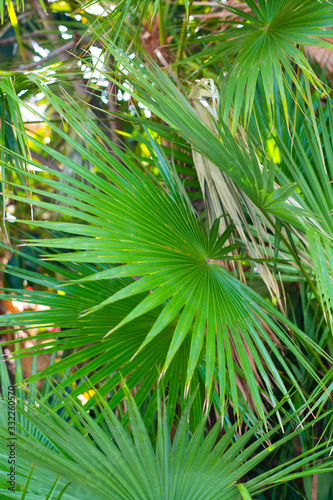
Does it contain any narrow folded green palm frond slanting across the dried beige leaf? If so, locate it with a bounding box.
[93,44,304,227]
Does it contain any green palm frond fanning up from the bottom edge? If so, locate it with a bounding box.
[0,386,331,500]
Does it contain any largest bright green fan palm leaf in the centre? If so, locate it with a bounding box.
[0,82,326,416]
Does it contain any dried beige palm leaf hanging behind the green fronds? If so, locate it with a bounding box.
[190,79,282,308]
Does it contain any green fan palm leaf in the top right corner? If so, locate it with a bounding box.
[191,0,333,131]
